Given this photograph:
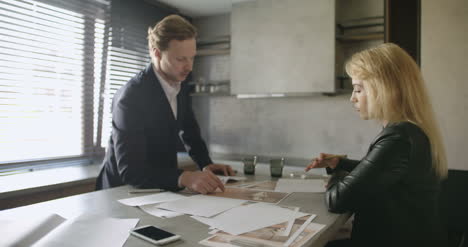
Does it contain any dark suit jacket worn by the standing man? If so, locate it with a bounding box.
[96,64,212,190]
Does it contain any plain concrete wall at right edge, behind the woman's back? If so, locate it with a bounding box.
[421,0,468,170]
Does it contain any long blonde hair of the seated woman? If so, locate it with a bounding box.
[346,43,447,178]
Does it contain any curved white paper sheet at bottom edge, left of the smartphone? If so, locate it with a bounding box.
[33,217,139,247]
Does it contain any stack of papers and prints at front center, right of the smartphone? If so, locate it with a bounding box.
[192,203,325,247]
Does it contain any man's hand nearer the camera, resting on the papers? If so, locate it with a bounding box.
[180,170,224,194]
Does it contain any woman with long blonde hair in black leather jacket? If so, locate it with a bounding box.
[306,43,447,246]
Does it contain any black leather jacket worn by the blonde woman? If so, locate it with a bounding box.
[326,122,444,246]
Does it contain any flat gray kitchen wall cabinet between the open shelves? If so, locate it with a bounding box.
[230,0,336,95]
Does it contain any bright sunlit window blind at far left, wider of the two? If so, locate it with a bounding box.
[0,0,110,164]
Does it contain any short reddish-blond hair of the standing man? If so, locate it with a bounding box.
[148,15,197,56]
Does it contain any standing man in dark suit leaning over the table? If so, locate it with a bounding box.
[96,15,234,194]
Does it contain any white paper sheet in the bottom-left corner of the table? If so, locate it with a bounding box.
[0,214,65,246]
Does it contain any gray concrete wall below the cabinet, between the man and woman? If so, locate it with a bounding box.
[193,0,383,165]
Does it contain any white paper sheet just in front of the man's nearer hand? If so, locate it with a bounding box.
[158,195,246,217]
